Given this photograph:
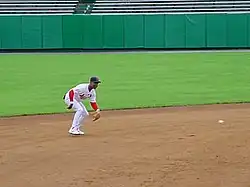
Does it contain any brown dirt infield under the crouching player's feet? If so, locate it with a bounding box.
[0,104,250,187]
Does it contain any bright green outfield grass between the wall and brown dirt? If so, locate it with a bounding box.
[0,52,250,116]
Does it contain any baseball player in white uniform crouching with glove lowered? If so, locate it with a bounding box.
[63,77,101,135]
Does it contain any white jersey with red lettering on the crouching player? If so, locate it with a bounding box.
[69,83,96,102]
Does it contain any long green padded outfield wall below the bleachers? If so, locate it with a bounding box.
[0,14,250,49]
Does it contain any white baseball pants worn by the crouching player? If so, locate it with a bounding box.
[64,93,89,130]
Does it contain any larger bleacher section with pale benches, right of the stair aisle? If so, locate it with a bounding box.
[91,0,250,14]
